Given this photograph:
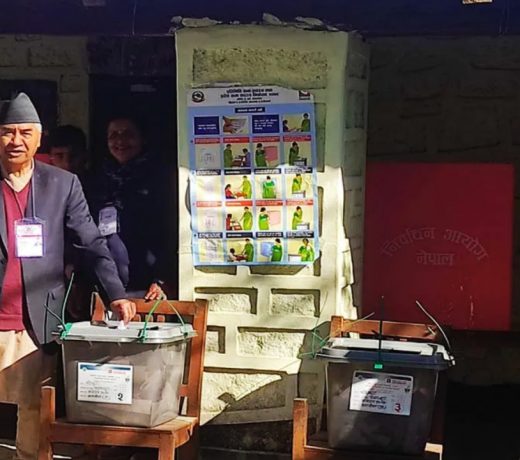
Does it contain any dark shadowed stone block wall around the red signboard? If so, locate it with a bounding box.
[368,37,520,385]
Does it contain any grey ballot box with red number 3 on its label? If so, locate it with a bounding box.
[317,338,453,455]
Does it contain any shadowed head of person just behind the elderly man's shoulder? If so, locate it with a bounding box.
[49,125,87,179]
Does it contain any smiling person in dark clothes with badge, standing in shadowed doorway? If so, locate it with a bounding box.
[86,115,169,300]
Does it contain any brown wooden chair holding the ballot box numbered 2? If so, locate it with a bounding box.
[38,296,208,460]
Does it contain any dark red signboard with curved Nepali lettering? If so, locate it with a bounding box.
[362,163,514,330]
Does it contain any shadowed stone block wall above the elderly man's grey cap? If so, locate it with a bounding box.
[0,35,89,132]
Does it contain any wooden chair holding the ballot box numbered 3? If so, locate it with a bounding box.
[292,316,447,460]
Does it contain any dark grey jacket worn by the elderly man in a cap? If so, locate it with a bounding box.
[0,161,125,344]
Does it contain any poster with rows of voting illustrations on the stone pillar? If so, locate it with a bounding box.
[188,86,319,265]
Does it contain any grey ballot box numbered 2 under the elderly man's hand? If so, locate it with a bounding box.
[61,321,195,427]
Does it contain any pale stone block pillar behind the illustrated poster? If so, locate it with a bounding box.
[176,26,369,442]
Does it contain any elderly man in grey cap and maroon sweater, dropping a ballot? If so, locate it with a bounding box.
[0,93,135,460]
